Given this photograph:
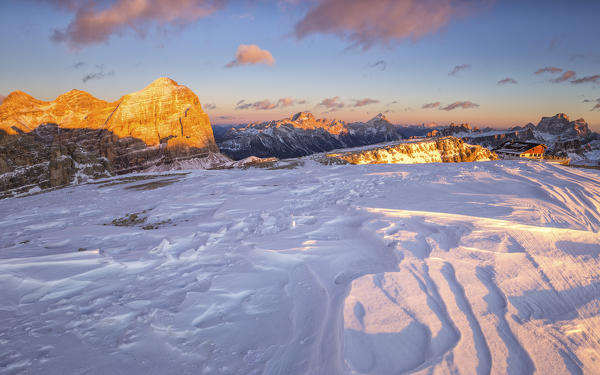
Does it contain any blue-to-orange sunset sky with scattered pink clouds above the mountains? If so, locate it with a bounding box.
[0,0,600,131]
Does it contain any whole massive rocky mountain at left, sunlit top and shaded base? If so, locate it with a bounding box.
[0,78,218,198]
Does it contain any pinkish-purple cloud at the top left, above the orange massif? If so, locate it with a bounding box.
[45,0,226,49]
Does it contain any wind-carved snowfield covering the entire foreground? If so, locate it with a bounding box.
[0,161,600,374]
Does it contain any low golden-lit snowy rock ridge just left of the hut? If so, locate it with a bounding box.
[324,137,498,164]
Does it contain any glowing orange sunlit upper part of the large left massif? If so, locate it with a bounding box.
[0,78,218,152]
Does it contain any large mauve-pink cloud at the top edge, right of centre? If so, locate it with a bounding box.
[294,0,490,49]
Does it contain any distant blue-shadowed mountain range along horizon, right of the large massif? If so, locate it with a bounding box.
[216,112,600,164]
